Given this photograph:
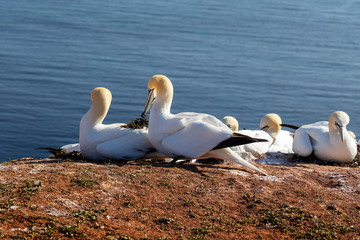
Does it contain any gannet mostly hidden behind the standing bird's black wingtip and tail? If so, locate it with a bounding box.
[223,116,274,160]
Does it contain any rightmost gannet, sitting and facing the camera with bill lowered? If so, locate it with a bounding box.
[293,111,357,162]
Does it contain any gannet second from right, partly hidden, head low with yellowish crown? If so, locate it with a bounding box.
[259,113,296,153]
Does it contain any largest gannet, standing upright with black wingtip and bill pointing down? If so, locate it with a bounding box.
[143,75,266,174]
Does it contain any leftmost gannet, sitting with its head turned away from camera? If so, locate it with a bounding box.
[79,87,162,161]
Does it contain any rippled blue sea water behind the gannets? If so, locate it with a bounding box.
[0,0,360,162]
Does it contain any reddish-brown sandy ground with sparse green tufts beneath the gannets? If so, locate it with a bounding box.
[0,155,360,239]
